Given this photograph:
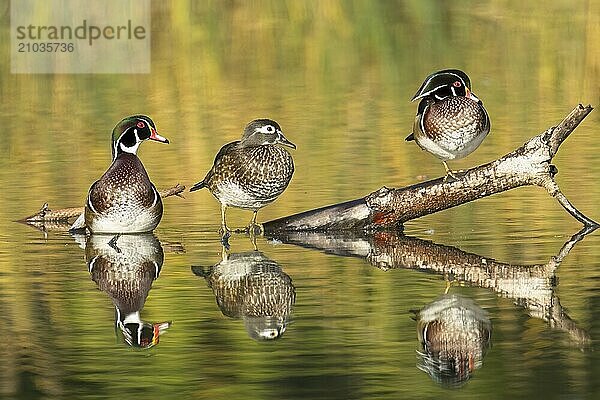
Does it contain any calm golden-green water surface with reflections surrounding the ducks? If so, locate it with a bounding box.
[0,1,600,399]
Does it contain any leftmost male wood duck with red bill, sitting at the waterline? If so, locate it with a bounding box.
[71,115,169,233]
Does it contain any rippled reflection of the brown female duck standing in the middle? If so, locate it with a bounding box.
[192,248,296,341]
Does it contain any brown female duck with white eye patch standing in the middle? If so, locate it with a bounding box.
[190,119,296,237]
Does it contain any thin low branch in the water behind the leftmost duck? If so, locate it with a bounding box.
[17,183,185,230]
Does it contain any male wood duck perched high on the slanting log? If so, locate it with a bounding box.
[406,69,490,179]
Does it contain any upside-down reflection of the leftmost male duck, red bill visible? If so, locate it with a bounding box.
[85,233,171,349]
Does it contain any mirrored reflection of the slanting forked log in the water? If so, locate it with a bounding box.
[271,227,595,345]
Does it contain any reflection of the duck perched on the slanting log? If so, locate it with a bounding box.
[416,294,492,387]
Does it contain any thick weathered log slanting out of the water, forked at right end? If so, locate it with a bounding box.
[264,105,598,233]
